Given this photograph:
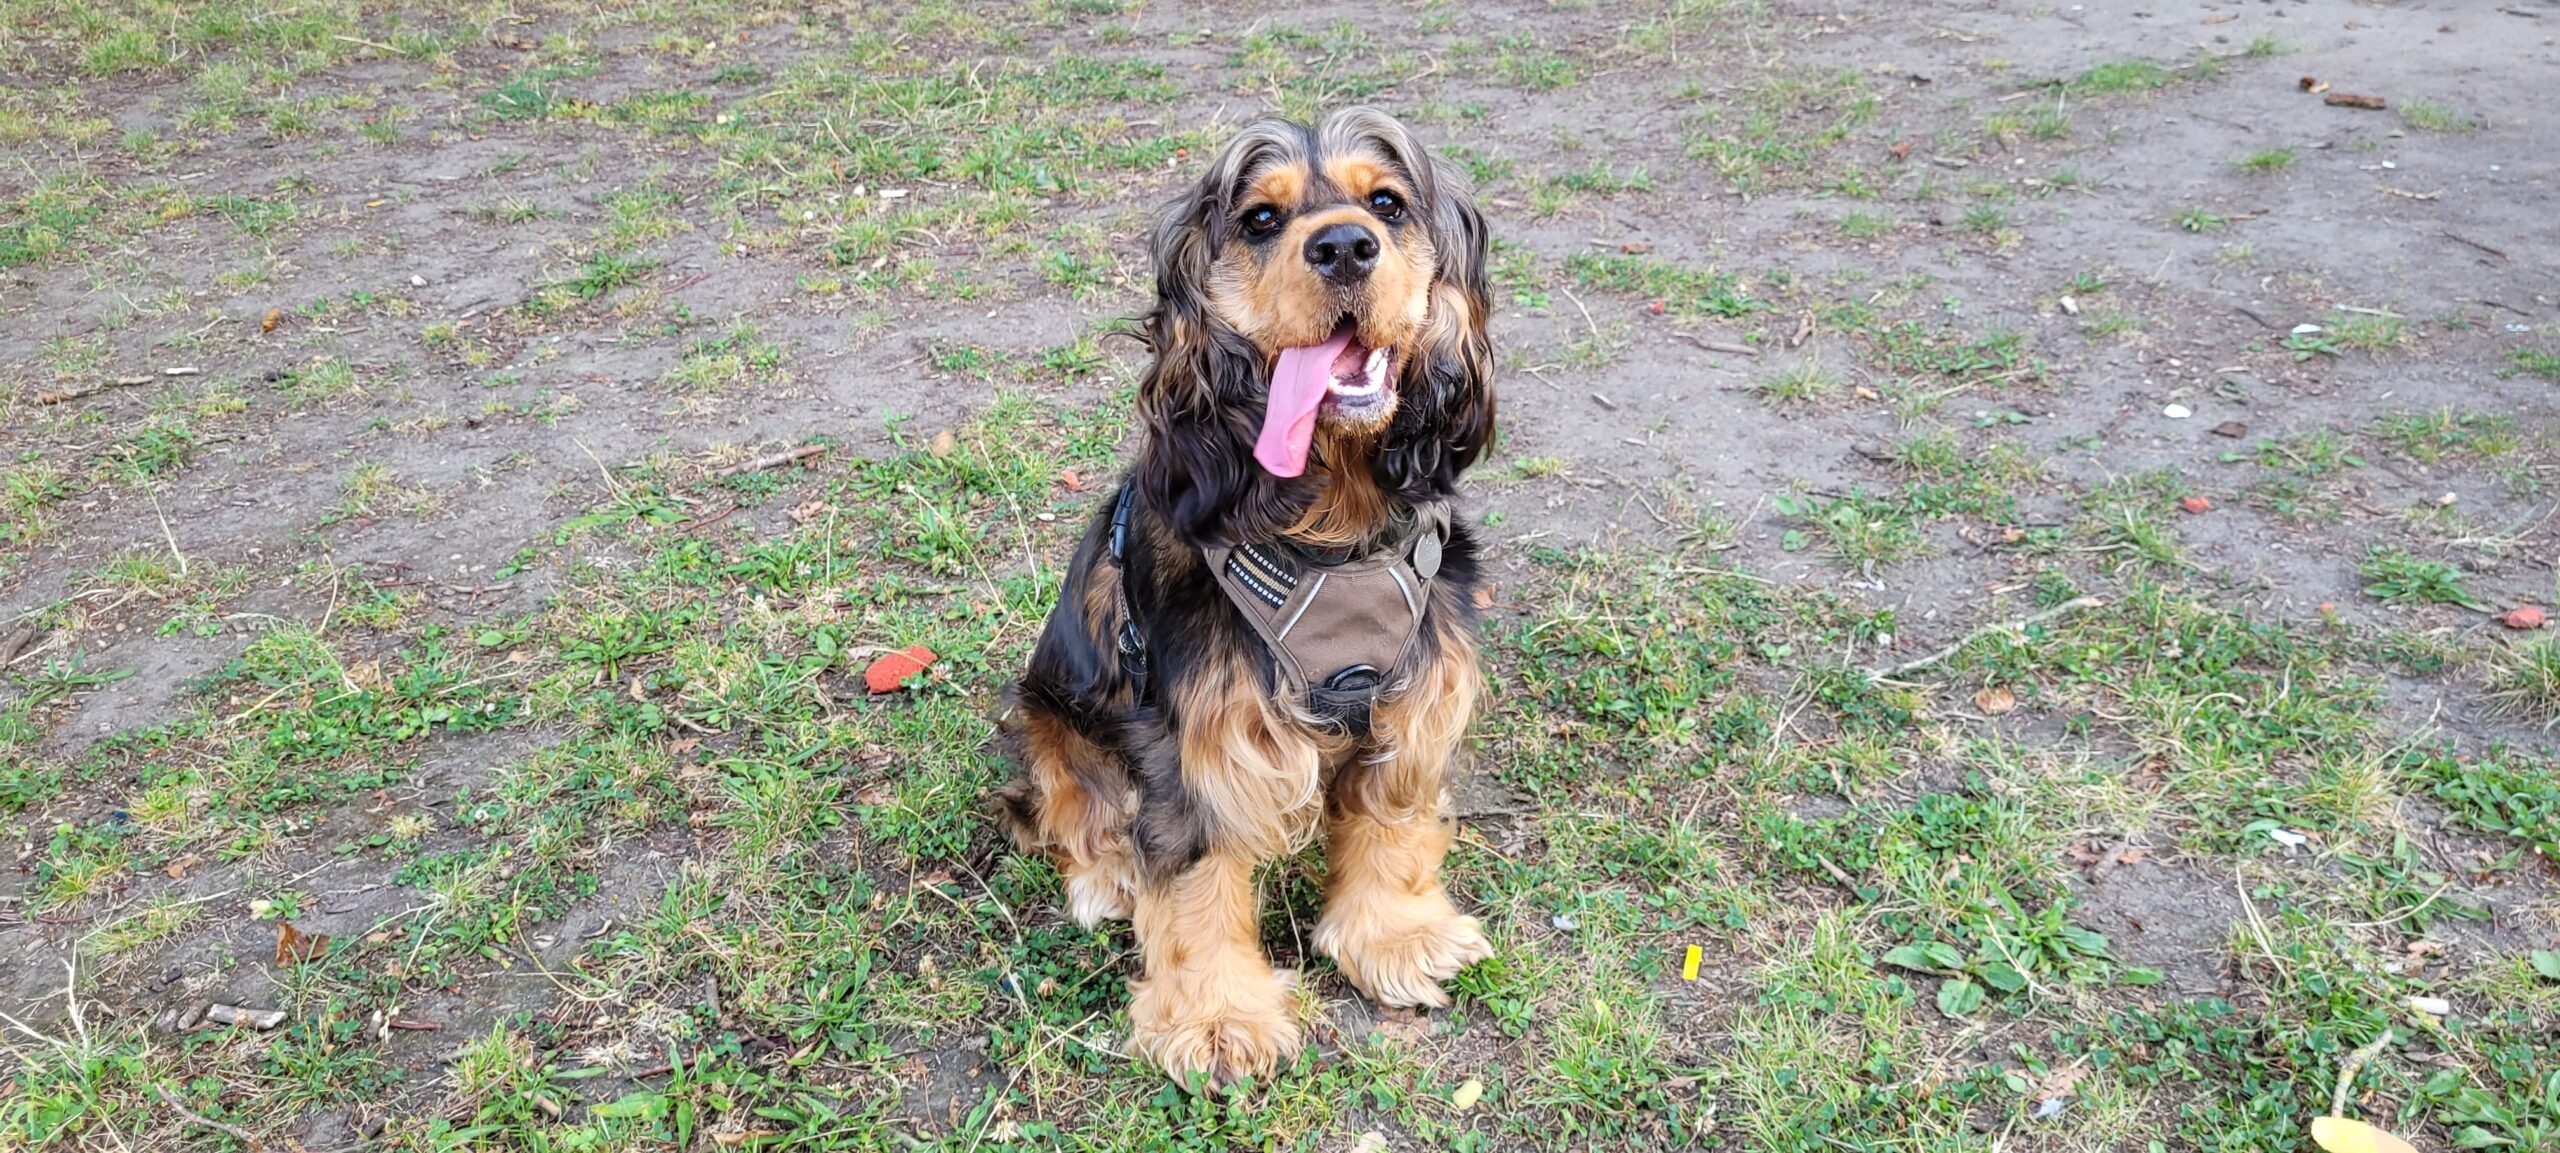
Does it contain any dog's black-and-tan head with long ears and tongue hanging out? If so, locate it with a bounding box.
[1139,108,1492,543]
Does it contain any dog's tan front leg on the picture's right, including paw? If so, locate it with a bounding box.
[1316,635,1492,1007]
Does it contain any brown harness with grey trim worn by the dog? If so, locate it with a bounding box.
[1111,487,1449,730]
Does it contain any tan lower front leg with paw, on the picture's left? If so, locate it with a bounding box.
[1129,853,1298,1086]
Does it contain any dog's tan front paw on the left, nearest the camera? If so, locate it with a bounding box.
[1129,969,1300,1089]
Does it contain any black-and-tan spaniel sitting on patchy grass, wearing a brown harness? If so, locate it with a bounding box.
[996,108,1495,1086]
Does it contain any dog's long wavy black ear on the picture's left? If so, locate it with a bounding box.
[1137,123,1308,546]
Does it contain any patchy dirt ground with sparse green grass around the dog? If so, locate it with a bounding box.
[0,0,2560,1150]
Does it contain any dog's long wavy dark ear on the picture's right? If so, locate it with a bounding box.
[1344,110,1492,500]
